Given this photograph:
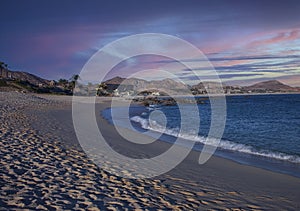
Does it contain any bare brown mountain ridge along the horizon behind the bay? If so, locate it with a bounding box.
[0,67,300,94]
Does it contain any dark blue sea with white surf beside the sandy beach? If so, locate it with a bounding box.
[102,94,300,178]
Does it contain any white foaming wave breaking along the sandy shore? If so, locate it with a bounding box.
[131,116,300,163]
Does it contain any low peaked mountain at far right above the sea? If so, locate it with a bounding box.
[243,80,300,92]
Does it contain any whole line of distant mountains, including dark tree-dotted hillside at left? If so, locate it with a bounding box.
[0,67,300,95]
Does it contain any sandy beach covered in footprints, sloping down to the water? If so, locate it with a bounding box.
[0,92,300,210]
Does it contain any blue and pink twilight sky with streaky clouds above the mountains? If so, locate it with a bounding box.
[0,0,300,86]
